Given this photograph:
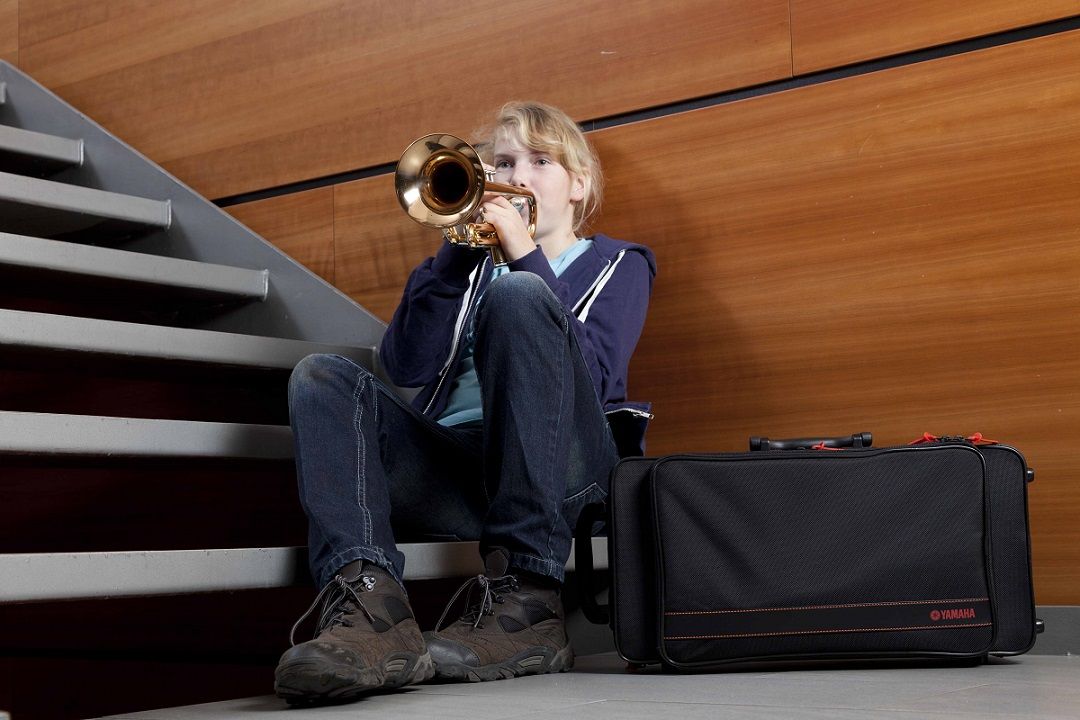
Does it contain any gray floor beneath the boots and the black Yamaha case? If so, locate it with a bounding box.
[99,653,1080,720]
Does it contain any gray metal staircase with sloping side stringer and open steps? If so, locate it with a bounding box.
[0,63,384,602]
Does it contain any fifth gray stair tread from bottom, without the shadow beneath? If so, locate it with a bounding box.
[0,172,172,228]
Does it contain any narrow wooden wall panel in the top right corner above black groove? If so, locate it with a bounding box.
[791,0,1080,74]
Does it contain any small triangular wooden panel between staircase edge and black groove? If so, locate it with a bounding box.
[225,188,335,284]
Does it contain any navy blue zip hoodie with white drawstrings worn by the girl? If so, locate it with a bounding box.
[379,234,657,451]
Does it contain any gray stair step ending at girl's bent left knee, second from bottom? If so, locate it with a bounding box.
[0,411,293,460]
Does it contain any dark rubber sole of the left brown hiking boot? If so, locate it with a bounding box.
[274,653,435,705]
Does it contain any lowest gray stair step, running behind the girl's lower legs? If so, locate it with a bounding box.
[0,538,608,602]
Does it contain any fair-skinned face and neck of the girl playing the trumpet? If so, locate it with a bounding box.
[494,133,585,243]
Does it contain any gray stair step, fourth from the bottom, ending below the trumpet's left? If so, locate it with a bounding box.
[0,232,269,300]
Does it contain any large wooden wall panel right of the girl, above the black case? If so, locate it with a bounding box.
[594,31,1080,603]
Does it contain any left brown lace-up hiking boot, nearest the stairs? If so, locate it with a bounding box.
[274,560,434,705]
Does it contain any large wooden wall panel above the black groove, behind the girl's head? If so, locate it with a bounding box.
[21,0,791,198]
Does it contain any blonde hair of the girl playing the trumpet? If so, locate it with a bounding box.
[476,100,604,232]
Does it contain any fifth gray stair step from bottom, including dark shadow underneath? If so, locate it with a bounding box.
[0,172,172,235]
